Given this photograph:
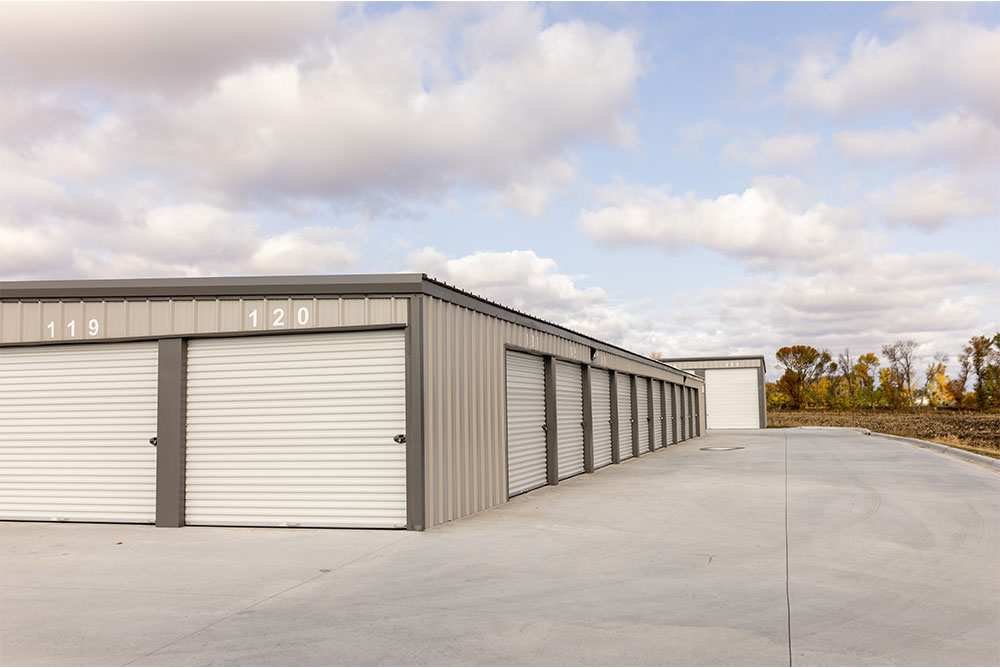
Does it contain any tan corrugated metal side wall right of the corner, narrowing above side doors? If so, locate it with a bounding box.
[423,295,700,527]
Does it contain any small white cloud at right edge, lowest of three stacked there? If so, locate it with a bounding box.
[868,171,1000,229]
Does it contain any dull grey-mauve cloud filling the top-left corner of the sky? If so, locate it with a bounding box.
[0,2,338,95]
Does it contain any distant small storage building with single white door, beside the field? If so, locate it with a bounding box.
[663,355,767,429]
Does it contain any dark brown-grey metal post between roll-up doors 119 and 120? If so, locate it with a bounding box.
[156,338,187,527]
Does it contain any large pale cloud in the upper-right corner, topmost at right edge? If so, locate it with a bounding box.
[784,20,1000,117]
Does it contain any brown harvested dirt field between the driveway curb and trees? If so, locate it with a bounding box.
[767,408,1000,457]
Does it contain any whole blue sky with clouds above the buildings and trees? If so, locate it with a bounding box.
[0,2,1000,379]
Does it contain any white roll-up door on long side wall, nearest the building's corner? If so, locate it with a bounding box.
[507,351,548,496]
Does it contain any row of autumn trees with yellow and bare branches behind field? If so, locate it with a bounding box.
[767,333,1000,410]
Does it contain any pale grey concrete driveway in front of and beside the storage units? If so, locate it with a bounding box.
[0,429,1000,665]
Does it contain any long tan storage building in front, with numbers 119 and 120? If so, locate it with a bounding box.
[0,274,705,530]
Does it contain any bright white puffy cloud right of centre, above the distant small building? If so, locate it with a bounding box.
[577,182,874,267]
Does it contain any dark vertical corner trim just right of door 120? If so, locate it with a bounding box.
[404,295,427,531]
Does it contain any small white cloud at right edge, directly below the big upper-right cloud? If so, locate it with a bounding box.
[833,111,1000,166]
